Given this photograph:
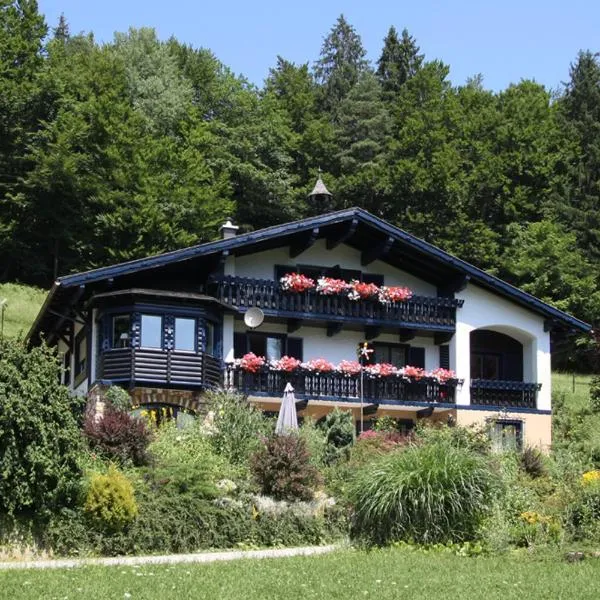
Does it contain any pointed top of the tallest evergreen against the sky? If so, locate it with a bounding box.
[314,15,369,110]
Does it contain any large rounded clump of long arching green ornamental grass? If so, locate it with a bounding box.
[350,442,494,545]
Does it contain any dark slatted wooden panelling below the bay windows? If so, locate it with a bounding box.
[97,348,222,387]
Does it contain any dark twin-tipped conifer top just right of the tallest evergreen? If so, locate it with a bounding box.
[377,25,424,97]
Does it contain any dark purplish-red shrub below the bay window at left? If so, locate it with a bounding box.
[83,406,152,466]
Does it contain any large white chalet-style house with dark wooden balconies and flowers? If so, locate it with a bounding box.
[29,202,590,448]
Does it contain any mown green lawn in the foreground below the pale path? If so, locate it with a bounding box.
[0,550,600,600]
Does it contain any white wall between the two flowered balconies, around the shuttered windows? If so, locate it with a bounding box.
[232,319,439,370]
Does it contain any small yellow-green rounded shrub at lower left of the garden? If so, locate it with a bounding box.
[84,467,138,531]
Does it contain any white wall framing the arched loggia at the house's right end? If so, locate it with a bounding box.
[450,283,551,410]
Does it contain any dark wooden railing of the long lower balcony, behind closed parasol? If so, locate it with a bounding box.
[225,365,459,404]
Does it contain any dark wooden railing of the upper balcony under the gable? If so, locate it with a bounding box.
[208,276,463,331]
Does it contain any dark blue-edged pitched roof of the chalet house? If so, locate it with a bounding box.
[28,208,591,337]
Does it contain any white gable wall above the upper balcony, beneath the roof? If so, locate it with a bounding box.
[232,240,436,296]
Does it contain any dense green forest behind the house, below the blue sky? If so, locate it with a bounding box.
[0,0,600,369]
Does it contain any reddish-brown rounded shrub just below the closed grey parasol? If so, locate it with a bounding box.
[250,434,320,500]
